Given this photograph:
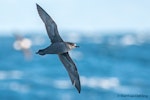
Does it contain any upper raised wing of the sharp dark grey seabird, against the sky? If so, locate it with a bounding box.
[36,4,63,43]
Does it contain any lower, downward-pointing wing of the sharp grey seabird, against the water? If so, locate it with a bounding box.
[59,52,81,93]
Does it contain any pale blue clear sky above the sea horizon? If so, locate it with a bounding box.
[0,0,150,32]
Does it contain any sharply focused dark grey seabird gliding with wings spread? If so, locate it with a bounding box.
[37,4,81,93]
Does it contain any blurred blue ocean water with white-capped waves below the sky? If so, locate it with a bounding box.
[0,33,150,100]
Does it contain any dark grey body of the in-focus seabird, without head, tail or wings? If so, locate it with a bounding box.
[46,42,69,54]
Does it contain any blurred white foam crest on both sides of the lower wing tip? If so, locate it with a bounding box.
[53,76,142,94]
